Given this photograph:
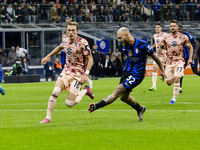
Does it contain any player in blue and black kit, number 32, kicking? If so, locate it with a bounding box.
[88,27,164,121]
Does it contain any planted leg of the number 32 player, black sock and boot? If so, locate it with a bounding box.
[120,92,146,121]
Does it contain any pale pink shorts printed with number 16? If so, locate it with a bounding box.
[57,73,82,96]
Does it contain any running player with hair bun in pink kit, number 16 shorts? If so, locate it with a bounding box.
[40,18,94,123]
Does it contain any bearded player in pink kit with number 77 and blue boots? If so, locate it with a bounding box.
[159,20,193,104]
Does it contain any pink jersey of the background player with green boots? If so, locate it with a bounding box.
[153,32,167,57]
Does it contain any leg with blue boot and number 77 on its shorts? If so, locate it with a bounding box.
[169,62,184,104]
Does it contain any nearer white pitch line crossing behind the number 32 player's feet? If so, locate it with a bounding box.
[0,109,200,112]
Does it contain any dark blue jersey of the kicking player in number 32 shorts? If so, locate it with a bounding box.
[120,38,153,76]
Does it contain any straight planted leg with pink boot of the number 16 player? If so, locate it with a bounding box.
[40,78,65,123]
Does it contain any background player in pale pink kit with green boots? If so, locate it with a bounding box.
[149,22,167,91]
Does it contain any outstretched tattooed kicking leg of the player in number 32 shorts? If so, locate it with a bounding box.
[88,84,126,113]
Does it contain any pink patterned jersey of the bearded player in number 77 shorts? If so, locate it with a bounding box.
[160,33,191,65]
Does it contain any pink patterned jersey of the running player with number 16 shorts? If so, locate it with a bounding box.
[61,36,91,80]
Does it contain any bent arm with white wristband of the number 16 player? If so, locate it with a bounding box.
[81,45,93,83]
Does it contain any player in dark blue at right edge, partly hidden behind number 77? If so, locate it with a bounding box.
[178,25,200,93]
